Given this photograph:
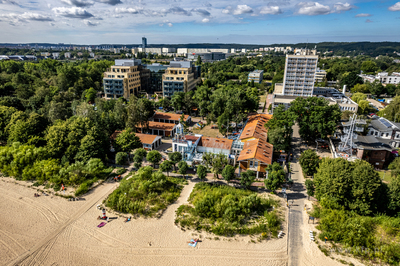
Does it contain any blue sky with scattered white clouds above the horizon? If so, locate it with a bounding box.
[0,0,400,45]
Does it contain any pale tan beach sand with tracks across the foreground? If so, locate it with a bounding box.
[0,178,350,266]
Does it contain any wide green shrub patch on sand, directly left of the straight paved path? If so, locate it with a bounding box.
[175,182,281,239]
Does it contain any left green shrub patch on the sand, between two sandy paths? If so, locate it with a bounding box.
[105,166,187,217]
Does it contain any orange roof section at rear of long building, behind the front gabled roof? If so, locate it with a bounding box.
[239,114,272,140]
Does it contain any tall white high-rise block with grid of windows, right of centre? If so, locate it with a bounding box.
[281,49,318,97]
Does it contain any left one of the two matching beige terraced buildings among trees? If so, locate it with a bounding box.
[103,59,142,99]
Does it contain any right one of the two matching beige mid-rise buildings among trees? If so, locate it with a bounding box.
[163,61,201,97]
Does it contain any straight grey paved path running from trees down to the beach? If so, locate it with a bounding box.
[288,125,306,266]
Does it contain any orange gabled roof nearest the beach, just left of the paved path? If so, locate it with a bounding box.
[238,139,273,164]
